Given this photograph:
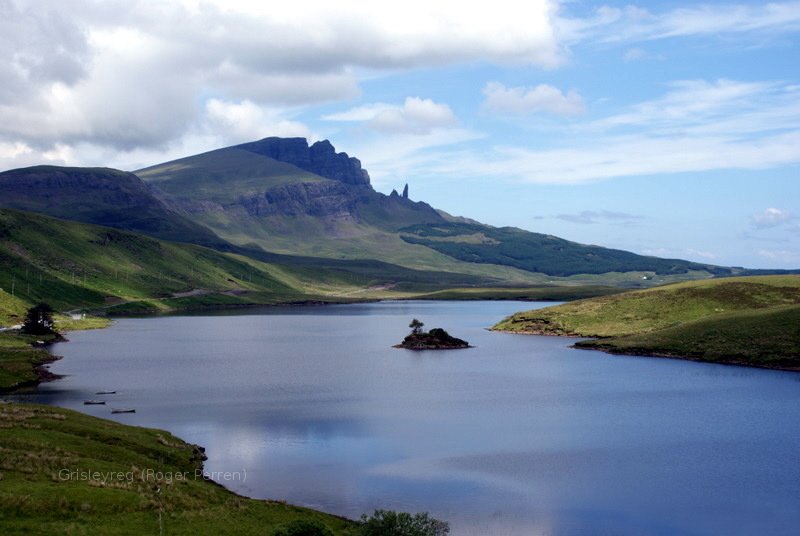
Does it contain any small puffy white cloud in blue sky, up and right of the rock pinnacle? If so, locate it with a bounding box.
[483,82,584,116]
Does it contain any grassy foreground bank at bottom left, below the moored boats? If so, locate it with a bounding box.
[0,404,353,536]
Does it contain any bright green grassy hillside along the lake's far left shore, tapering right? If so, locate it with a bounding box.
[0,210,614,320]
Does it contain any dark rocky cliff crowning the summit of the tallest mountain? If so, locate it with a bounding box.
[237,137,369,187]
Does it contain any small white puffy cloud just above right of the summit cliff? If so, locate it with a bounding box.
[323,97,457,134]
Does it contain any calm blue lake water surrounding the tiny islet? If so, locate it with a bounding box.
[6,302,800,536]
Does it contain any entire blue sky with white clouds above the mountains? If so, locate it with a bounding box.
[0,0,800,268]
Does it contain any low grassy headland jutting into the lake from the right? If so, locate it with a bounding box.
[493,275,800,370]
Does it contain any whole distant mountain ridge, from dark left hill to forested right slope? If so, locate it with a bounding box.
[0,137,792,286]
